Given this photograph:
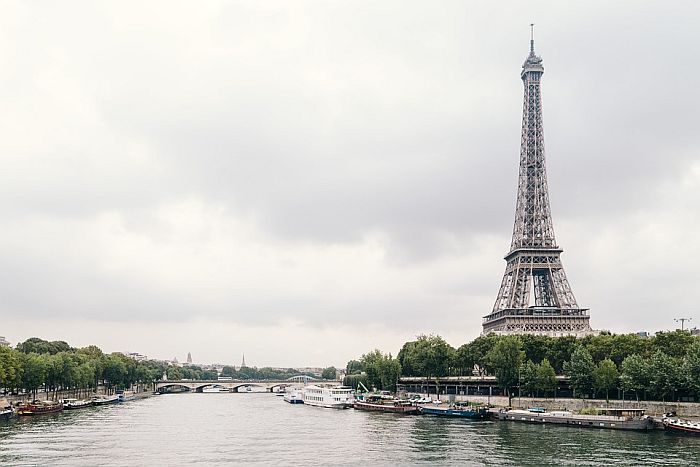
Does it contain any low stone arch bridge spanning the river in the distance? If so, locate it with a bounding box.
[153,375,341,392]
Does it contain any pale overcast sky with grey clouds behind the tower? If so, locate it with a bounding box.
[0,0,700,366]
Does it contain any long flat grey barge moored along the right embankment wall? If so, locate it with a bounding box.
[498,407,654,431]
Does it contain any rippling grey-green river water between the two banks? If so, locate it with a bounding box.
[0,393,700,466]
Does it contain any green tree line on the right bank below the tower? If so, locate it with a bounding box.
[345,330,700,400]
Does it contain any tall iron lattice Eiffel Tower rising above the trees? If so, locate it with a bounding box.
[482,25,592,336]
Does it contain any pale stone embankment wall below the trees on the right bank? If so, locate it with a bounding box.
[410,394,700,419]
